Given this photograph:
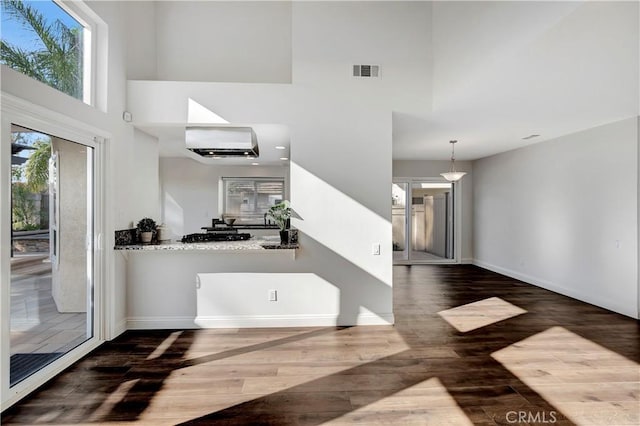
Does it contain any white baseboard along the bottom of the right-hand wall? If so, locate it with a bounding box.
[473,259,638,319]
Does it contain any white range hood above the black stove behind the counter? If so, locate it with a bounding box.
[185,126,260,158]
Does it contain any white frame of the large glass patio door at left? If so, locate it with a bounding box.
[0,93,109,410]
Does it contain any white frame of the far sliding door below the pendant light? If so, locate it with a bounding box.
[392,176,464,265]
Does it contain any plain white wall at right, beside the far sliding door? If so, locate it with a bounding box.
[473,117,638,318]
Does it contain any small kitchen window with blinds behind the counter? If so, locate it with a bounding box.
[222,177,285,224]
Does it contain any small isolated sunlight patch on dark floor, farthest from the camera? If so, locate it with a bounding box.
[438,297,527,333]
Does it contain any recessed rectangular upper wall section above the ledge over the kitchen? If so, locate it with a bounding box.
[154,1,291,83]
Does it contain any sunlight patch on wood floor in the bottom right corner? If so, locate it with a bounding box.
[491,327,640,425]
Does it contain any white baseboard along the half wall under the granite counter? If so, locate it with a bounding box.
[127,312,395,330]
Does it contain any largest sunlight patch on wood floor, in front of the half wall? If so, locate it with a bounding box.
[138,326,412,424]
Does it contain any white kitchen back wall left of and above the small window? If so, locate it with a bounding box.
[160,158,289,238]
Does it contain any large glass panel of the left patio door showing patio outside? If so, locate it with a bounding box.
[10,125,94,386]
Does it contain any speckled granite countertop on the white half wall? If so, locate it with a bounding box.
[114,236,298,251]
